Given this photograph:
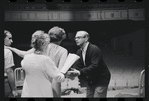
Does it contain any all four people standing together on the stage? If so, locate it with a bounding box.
[4,26,111,97]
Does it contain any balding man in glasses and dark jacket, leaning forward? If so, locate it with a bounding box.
[67,31,111,98]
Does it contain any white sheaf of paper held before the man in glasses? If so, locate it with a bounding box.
[61,53,80,73]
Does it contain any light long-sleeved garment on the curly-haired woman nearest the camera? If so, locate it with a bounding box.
[21,53,65,97]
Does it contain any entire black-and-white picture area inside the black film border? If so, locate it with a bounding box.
[3,2,148,101]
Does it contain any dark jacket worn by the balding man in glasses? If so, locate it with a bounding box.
[73,43,111,85]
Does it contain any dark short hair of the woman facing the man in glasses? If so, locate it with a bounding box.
[48,26,65,42]
